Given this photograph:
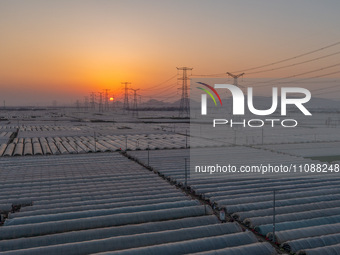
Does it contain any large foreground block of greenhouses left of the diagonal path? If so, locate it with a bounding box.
[0,153,277,255]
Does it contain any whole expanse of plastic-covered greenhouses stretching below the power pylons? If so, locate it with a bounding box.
[0,108,340,255]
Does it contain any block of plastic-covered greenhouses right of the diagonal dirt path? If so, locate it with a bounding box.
[129,146,340,255]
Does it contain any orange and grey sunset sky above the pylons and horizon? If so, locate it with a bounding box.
[0,0,340,105]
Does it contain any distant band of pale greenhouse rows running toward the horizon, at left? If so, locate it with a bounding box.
[0,134,227,157]
